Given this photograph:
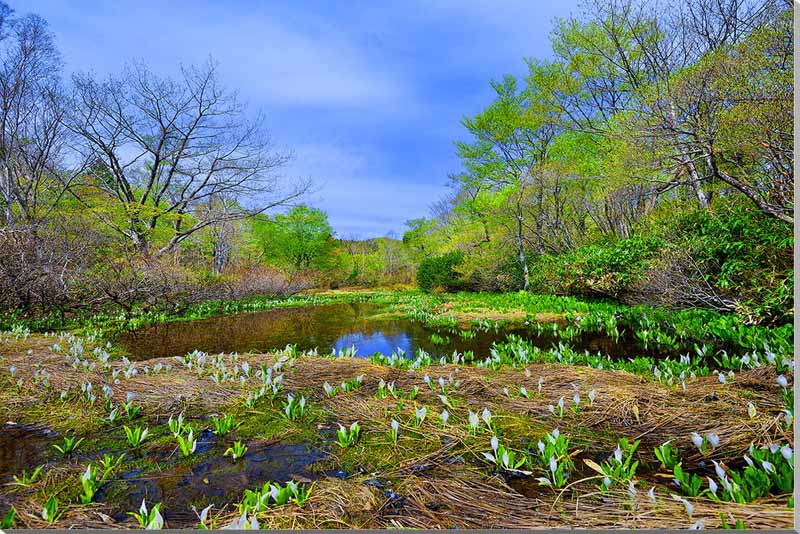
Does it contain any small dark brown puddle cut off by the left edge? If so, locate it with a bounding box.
[0,422,57,483]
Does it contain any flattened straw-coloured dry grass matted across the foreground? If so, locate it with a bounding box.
[0,336,793,529]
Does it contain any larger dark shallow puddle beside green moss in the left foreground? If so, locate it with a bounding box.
[97,442,327,527]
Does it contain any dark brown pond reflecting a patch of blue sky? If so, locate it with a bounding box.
[120,303,645,360]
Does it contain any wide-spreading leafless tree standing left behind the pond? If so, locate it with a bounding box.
[69,61,308,257]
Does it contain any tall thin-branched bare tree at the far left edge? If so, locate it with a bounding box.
[0,7,69,226]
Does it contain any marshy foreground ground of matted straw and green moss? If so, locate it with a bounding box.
[0,312,793,528]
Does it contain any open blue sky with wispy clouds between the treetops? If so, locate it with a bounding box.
[21,0,576,238]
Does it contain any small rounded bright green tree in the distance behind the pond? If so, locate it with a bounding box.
[253,205,335,271]
